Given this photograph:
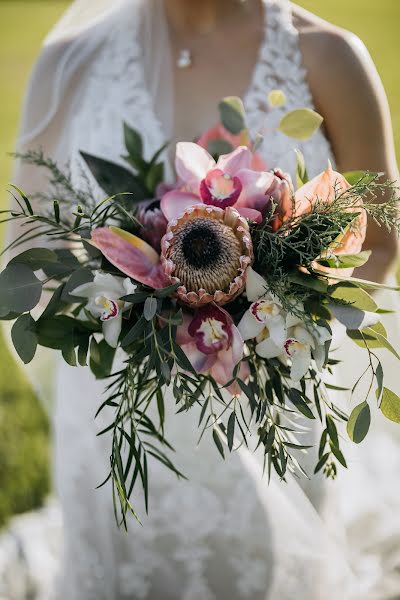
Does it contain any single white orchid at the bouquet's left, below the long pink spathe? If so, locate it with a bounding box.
[73,272,137,348]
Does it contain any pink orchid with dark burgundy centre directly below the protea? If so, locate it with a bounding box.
[176,304,248,394]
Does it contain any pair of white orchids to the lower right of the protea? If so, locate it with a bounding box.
[238,267,331,381]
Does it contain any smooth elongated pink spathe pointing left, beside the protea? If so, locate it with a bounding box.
[92,227,170,289]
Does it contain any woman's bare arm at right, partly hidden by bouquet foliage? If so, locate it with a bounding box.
[296,9,399,281]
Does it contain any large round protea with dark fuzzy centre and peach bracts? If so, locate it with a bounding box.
[161,204,253,306]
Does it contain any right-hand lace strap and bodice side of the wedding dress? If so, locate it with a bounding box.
[244,0,334,176]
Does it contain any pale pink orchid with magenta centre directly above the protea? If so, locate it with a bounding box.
[161,142,274,223]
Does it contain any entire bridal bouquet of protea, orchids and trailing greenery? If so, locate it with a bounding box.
[0,92,400,523]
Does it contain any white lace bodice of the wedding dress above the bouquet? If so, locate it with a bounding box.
[72,0,333,185]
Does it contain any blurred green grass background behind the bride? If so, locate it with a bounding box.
[0,0,400,526]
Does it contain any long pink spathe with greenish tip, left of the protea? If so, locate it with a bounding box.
[91,227,169,289]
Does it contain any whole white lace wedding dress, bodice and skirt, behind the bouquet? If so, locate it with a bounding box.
[55,0,354,600]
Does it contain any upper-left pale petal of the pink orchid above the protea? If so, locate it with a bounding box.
[175,142,215,193]
